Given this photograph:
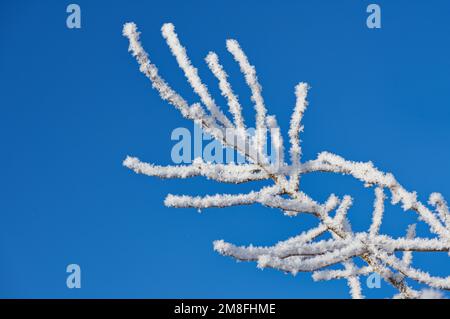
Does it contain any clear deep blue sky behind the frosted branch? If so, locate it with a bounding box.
[0,0,450,298]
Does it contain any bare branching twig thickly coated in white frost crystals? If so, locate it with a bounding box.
[123,23,450,299]
